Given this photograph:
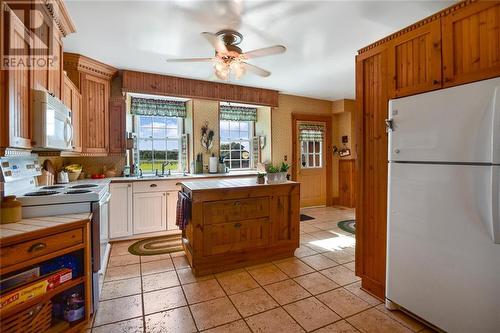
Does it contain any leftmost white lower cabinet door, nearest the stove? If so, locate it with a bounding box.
[109,183,133,239]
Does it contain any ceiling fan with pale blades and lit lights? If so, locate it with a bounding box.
[167,29,286,80]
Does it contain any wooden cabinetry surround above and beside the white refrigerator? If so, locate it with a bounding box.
[355,0,500,299]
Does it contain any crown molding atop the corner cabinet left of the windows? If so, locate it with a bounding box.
[63,52,118,80]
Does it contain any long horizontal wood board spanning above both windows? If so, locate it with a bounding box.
[122,71,278,107]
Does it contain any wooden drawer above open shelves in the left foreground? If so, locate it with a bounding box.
[0,229,83,268]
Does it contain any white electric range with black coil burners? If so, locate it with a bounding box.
[0,154,111,309]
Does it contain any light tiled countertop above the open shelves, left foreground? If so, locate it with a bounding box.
[0,213,92,240]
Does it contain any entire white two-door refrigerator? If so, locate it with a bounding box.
[386,78,500,333]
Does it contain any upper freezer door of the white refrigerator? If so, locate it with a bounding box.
[388,78,500,164]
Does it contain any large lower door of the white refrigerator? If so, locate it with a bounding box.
[386,163,500,333]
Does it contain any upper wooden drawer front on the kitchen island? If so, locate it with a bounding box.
[203,197,270,224]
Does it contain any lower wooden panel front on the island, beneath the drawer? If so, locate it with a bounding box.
[203,219,270,256]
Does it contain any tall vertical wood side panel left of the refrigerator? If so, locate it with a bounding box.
[355,45,388,298]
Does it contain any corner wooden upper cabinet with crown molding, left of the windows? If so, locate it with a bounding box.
[64,53,116,156]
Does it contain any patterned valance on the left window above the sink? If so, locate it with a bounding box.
[130,97,186,118]
